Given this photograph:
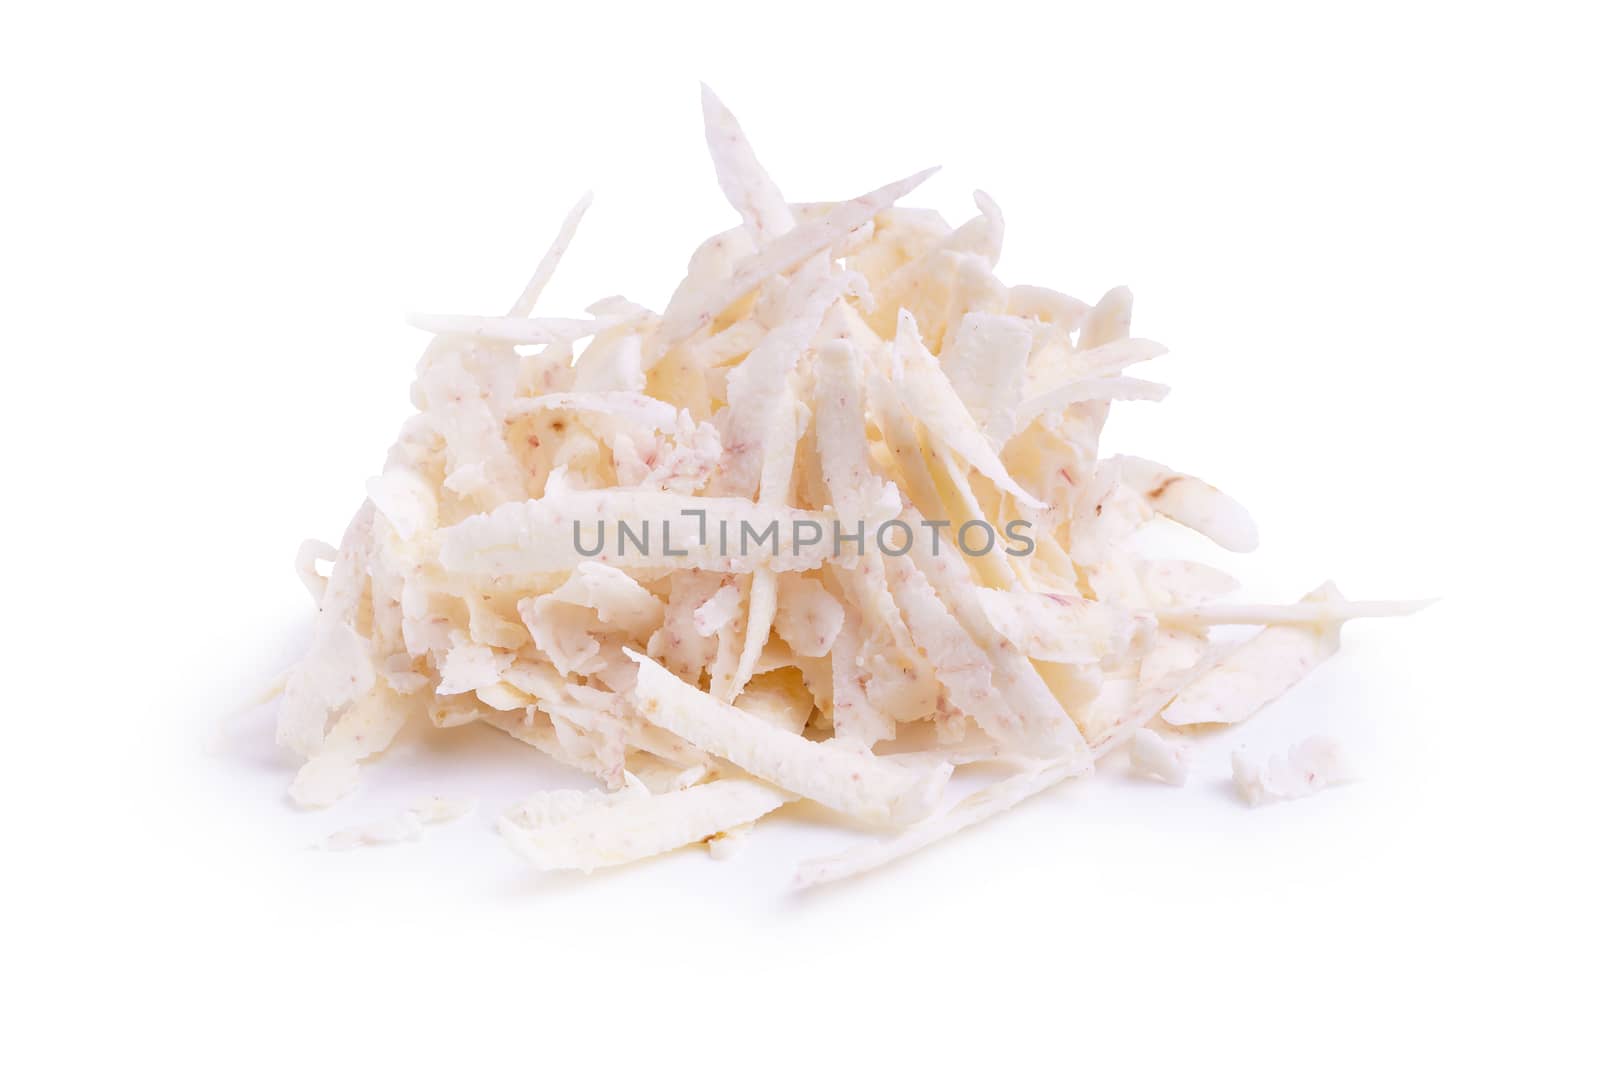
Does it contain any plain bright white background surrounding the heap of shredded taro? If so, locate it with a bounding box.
[0,0,1600,1063]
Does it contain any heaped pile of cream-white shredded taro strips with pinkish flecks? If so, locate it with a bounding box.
[265,91,1416,884]
